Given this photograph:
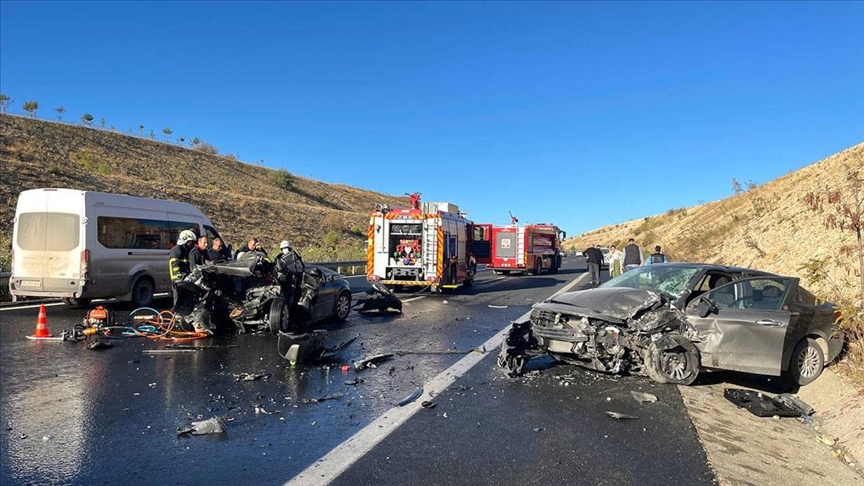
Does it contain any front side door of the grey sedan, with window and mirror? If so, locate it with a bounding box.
[686,276,797,376]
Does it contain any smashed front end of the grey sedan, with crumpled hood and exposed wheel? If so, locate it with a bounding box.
[498,288,699,384]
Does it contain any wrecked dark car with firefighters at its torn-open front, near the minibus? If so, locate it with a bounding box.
[180,255,351,334]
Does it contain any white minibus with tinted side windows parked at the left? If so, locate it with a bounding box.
[9,189,219,307]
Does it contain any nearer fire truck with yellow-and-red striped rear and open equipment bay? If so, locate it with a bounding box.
[366,193,492,292]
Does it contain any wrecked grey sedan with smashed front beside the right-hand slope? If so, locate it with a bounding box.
[498,263,842,385]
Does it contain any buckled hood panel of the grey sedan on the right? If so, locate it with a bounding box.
[534,287,665,324]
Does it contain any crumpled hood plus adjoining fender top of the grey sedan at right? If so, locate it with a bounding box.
[534,287,692,332]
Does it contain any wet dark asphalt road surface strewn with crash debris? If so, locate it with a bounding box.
[0,258,713,485]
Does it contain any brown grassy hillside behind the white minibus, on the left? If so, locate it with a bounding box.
[0,115,407,264]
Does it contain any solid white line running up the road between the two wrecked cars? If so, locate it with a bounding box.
[285,274,588,486]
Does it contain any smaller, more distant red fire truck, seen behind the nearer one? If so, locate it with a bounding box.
[488,223,567,275]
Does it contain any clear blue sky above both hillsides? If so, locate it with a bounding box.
[0,1,864,235]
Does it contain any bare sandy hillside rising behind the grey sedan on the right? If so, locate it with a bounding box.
[565,140,864,299]
